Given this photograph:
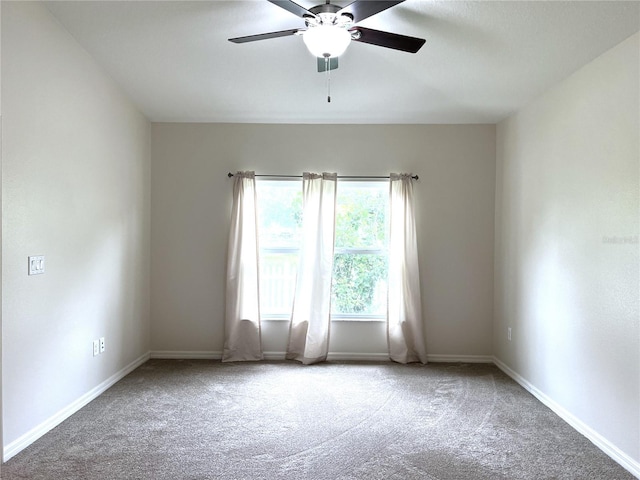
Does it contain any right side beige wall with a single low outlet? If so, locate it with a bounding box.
[494,34,640,468]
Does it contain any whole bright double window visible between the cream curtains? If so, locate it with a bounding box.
[256,180,389,320]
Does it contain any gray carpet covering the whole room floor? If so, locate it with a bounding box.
[1,360,634,480]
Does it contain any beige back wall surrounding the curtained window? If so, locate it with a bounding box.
[151,124,495,356]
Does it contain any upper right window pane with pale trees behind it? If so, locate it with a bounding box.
[335,182,389,249]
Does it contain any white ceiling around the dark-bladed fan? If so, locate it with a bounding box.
[47,0,640,123]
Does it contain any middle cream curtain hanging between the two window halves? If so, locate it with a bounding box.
[286,172,338,364]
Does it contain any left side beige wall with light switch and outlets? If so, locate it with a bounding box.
[2,2,150,450]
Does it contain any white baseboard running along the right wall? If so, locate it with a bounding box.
[493,357,640,479]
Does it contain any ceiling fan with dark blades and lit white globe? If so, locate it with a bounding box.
[229,0,425,72]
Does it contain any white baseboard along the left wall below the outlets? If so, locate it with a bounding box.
[2,353,149,462]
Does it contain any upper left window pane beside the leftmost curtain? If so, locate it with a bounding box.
[256,180,302,248]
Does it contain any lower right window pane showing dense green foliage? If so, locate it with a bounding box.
[331,253,387,315]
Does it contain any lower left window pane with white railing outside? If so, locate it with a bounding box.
[260,253,298,315]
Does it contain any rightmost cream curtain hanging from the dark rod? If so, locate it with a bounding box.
[387,173,427,363]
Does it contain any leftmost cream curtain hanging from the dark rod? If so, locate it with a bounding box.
[222,172,263,362]
